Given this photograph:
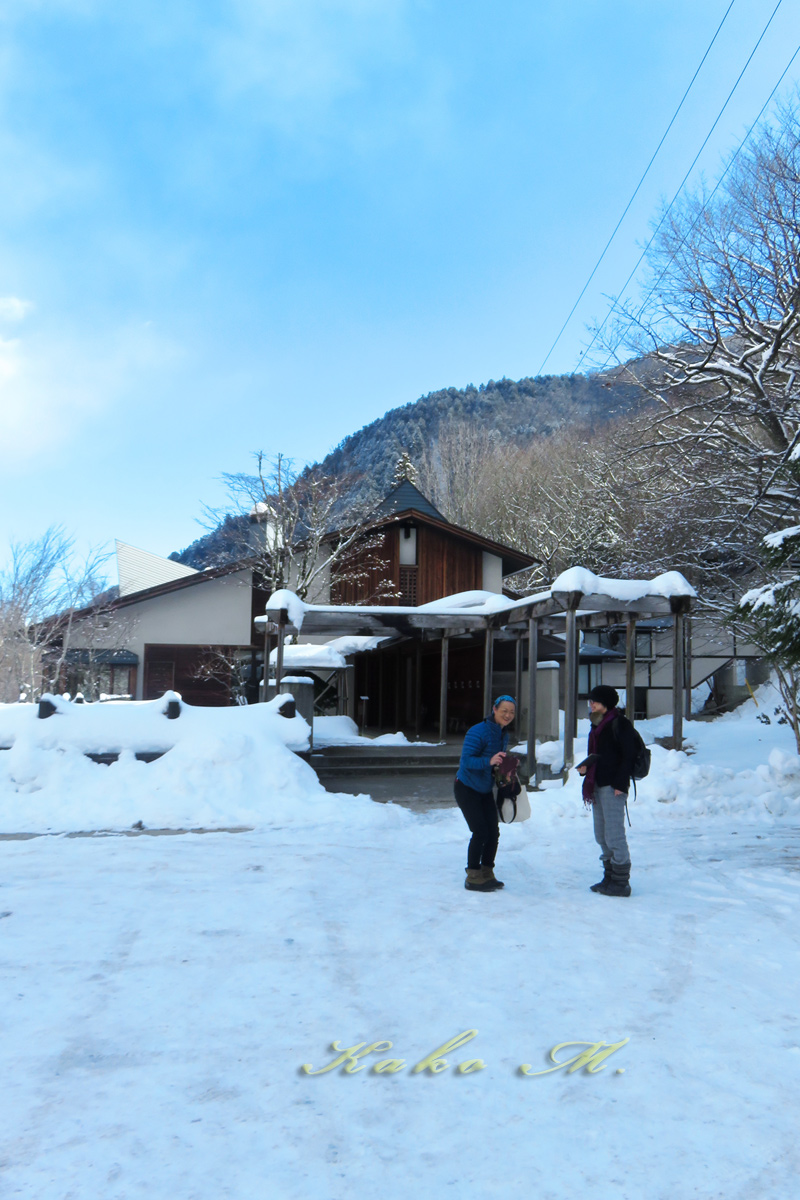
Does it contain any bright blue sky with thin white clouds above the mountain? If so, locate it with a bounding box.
[0,0,800,571]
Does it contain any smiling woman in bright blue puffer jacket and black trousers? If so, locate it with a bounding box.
[453,696,517,892]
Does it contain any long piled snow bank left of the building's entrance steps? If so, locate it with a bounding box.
[0,694,400,833]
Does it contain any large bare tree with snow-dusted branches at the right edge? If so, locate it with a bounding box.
[597,100,800,593]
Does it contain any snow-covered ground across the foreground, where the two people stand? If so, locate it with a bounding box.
[0,690,800,1200]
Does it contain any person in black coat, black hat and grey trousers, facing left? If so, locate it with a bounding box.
[578,684,636,896]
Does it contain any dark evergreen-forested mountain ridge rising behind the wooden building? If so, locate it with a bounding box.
[170,371,644,570]
